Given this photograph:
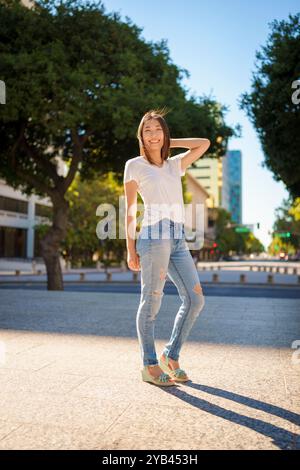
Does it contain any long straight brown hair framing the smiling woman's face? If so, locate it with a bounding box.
[136,109,170,165]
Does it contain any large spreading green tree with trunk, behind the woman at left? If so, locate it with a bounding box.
[0,0,235,290]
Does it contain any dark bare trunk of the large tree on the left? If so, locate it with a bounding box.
[40,199,69,290]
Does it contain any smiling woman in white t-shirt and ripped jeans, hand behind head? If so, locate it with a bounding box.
[124,110,210,386]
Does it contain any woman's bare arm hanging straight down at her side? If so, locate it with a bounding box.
[124,180,140,271]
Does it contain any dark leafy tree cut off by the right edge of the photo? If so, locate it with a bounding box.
[240,13,300,197]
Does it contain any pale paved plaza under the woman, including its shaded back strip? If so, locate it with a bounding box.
[0,289,300,450]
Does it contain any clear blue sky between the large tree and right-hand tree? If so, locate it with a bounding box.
[103,0,300,247]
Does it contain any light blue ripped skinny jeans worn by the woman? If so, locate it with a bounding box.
[136,219,205,366]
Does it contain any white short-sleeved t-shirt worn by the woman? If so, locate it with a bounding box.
[123,152,186,227]
